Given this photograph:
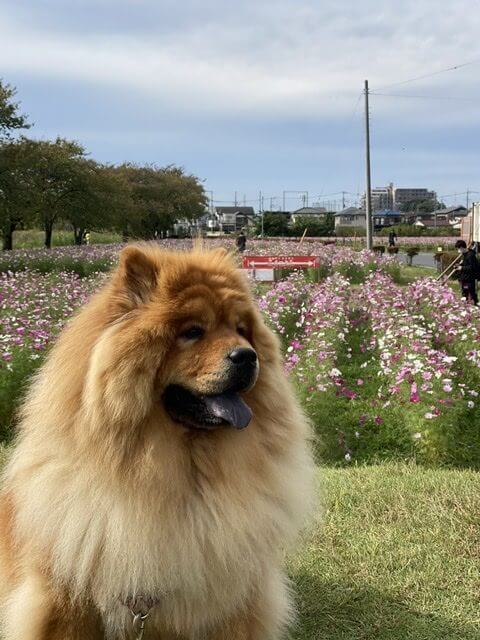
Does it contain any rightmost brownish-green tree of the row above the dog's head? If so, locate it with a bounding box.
[117,164,207,238]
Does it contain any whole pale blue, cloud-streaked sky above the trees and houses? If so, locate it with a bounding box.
[0,0,480,207]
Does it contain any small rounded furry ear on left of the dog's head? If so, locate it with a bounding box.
[118,245,158,306]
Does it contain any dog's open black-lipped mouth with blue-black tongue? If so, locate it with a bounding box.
[163,385,252,429]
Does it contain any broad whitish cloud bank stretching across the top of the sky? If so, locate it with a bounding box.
[0,0,480,124]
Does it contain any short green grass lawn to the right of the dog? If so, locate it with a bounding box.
[290,464,480,640]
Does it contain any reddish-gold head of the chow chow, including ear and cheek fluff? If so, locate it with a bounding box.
[86,245,277,430]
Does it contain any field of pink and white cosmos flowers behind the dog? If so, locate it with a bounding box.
[0,241,480,468]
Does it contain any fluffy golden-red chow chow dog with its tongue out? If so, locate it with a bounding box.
[0,244,313,640]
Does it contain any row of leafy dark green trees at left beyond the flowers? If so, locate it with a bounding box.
[0,79,207,250]
